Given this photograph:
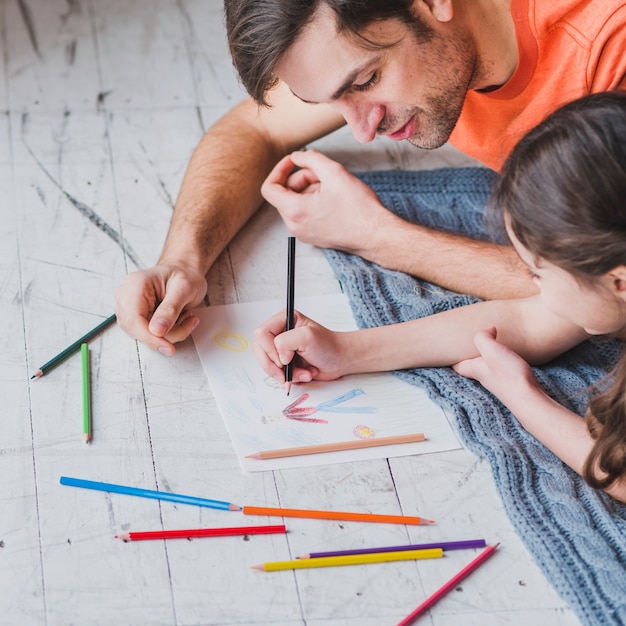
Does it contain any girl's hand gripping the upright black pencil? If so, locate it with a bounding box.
[253,311,349,383]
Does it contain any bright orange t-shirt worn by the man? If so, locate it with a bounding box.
[450,0,626,170]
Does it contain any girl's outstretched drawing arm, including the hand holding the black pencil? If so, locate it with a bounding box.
[255,296,587,382]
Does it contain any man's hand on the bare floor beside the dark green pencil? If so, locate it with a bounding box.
[115,265,207,356]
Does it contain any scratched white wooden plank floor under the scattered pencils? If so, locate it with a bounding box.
[0,0,579,626]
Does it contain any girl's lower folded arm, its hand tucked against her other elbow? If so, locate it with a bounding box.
[454,329,626,502]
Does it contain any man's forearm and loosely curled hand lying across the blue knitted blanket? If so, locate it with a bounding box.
[262,150,537,300]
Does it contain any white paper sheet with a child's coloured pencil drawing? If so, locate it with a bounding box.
[193,294,461,472]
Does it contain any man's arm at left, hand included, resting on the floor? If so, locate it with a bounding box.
[115,86,343,354]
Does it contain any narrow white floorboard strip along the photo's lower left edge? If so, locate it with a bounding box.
[0,127,45,624]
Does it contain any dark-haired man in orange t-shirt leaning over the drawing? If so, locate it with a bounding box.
[116,0,626,354]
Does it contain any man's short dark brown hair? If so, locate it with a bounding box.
[224,0,430,106]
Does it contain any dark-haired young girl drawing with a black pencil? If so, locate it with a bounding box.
[255,92,626,502]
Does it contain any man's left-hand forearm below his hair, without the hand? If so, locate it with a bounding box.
[159,86,343,274]
